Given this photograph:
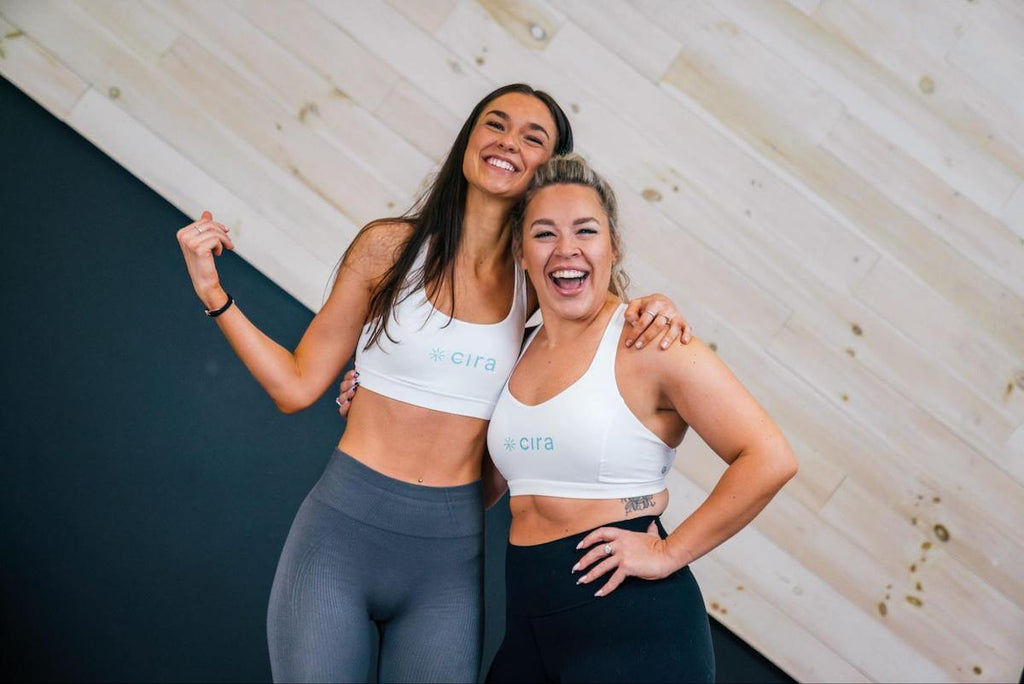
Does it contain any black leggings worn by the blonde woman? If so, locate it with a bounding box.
[487,516,715,683]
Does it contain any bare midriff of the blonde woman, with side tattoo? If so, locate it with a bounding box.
[509,489,669,546]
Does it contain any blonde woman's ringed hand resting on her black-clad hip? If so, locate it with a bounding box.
[572,521,682,596]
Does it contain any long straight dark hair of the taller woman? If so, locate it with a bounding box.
[356,83,572,347]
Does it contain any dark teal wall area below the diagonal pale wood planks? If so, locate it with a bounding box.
[0,79,786,682]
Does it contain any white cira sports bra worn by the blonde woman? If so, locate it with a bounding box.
[487,304,676,499]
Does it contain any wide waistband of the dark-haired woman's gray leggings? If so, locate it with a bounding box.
[309,448,483,539]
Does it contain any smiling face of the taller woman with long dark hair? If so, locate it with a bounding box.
[462,92,557,200]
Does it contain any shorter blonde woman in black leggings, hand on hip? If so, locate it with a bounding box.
[487,156,797,682]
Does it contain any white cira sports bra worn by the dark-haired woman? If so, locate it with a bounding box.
[355,246,526,420]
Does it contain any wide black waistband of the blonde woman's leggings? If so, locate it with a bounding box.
[505,515,668,616]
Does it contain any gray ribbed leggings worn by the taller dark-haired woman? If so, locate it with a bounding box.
[266,451,483,682]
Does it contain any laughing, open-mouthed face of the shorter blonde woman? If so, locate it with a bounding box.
[520,184,617,319]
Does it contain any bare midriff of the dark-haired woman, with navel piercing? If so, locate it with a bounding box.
[338,387,487,486]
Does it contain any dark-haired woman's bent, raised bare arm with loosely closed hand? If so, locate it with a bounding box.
[177,212,409,413]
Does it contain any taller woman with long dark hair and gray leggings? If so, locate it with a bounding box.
[178,84,683,681]
